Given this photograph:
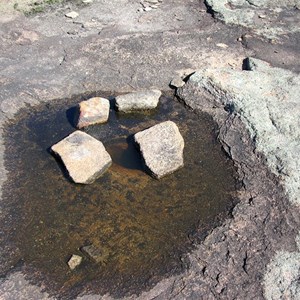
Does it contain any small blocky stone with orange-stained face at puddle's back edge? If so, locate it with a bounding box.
[77,97,109,129]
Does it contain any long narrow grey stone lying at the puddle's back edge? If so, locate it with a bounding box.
[116,90,161,112]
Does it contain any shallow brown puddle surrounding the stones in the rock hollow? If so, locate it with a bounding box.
[0,92,236,299]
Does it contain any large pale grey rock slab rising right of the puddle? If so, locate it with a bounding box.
[179,58,300,205]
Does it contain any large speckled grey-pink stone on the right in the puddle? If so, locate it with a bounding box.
[134,121,184,178]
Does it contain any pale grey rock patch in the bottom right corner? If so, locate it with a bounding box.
[264,252,300,300]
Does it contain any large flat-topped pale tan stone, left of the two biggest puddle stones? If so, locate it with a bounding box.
[51,130,112,184]
